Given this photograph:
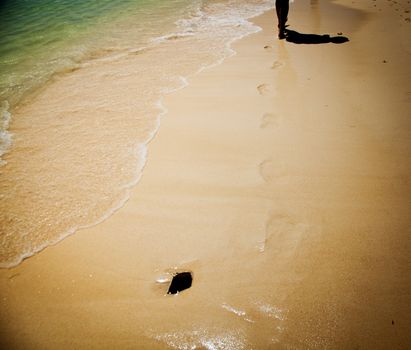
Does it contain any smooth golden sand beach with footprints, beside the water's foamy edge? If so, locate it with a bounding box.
[0,0,411,349]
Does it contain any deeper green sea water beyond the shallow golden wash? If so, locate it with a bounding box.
[0,0,196,106]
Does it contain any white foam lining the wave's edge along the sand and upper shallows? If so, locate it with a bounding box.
[0,1,273,268]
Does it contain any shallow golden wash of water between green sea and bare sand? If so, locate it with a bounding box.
[0,1,273,267]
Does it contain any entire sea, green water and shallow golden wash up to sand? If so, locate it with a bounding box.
[0,0,273,267]
